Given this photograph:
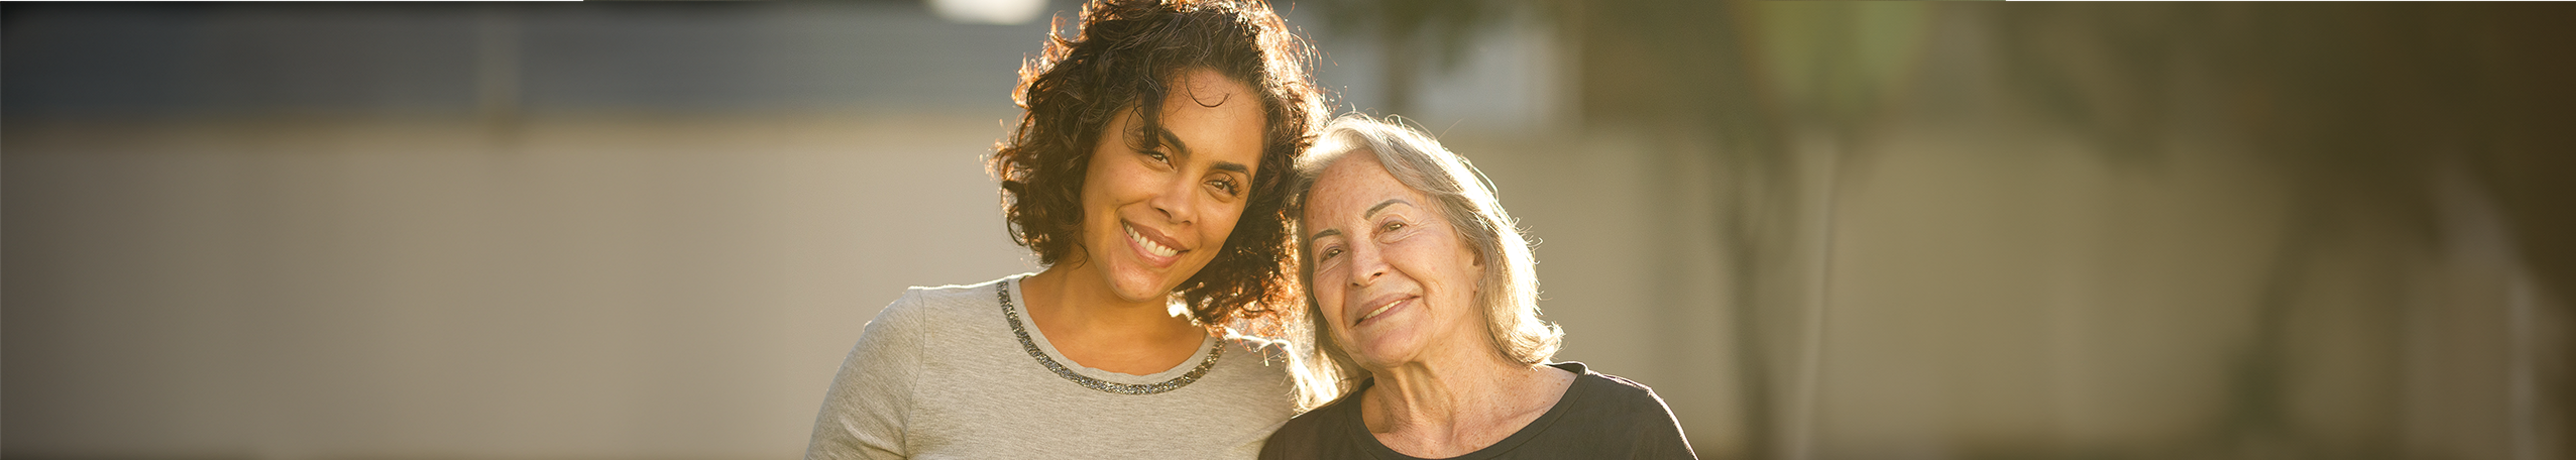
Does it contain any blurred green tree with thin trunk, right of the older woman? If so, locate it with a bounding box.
[1558,0,1929,457]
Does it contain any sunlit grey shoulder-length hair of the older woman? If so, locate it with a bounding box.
[1288,113,1564,408]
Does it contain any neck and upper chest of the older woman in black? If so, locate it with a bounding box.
[1360,347,1574,457]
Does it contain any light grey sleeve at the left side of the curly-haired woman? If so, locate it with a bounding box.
[806,291,922,460]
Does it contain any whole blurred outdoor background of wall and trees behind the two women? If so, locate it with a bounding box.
[0,0,2576,460]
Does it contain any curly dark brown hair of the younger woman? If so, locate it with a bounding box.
[987,0,1324,334]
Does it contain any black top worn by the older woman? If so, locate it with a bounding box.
[1262,362,1698,460]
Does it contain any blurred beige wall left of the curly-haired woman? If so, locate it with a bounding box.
[0,115,1030,457]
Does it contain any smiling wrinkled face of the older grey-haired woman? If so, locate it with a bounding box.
[1301,149,1492,370]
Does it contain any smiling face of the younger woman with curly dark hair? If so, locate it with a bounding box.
[1074,70,1265,303]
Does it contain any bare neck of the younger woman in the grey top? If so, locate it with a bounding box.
[1020,265,1206,375]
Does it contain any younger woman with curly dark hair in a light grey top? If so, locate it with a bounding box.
[806,0,1324,457]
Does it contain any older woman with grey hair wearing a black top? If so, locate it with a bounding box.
[1262,115,1695,460]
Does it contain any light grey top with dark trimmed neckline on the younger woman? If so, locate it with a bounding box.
[806,275,1296,460]
